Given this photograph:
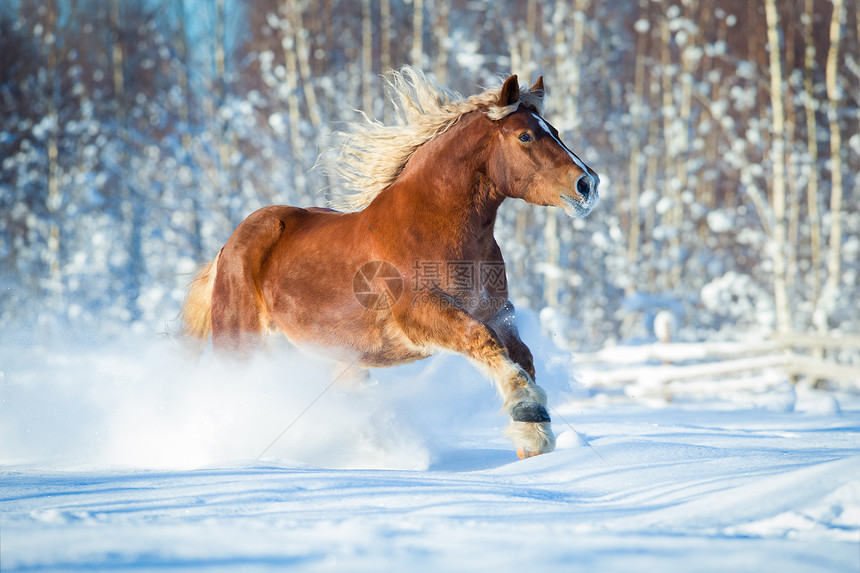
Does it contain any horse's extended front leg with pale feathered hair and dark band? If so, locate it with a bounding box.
[399,291,555,458]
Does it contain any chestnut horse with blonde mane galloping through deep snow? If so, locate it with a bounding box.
[181,66,600,459]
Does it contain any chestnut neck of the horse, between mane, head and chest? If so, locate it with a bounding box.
[368,114,504,251]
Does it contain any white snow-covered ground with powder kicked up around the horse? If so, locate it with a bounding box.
[0,318,860,573]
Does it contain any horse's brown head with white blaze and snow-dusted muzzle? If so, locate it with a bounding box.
[489,76,600,217]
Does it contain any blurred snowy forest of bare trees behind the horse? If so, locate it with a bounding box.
[0,0,860,348]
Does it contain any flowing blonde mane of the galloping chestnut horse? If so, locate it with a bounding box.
[332,66,543,211]
